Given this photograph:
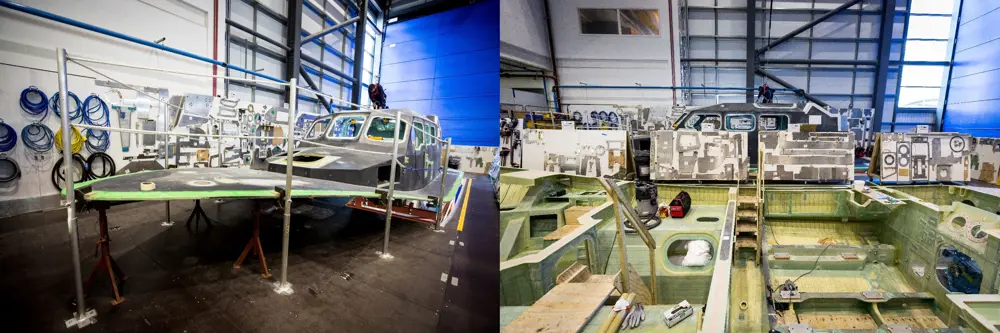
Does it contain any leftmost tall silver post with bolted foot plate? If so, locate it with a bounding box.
[56,48,97,328]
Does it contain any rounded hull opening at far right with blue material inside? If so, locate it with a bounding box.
[934,245,983,294]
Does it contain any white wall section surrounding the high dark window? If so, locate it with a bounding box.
[549,0,681,107]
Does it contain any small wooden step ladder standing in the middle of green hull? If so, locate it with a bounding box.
[734,143,764,265]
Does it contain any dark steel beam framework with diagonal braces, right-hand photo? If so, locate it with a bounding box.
[680,0,908,130]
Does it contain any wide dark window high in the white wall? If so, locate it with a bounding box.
[578,8,660,36]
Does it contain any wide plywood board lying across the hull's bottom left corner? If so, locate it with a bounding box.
[501,279,614,333]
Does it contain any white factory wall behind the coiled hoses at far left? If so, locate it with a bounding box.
[0,0,225,216]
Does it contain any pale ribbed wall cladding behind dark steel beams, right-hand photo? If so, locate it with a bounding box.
[681,0,906,113]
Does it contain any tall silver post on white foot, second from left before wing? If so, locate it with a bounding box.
[274,77,298,295]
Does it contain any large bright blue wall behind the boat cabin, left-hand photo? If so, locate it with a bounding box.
[381,0,500,146]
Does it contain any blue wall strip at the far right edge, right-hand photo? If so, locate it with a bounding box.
[942,0,1000,138]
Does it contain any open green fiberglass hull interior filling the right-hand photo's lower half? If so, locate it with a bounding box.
[499,170,1000,332]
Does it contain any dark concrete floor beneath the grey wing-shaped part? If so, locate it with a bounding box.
[0,172,499,332]
